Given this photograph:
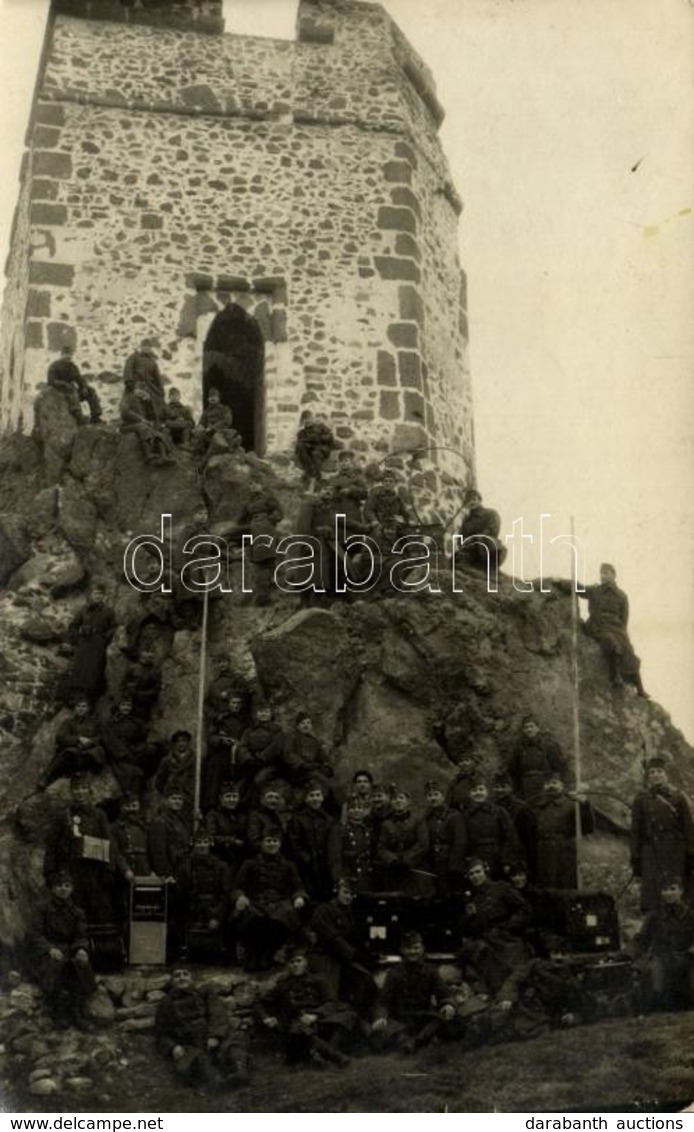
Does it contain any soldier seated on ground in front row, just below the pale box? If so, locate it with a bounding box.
[154,966,248,1087]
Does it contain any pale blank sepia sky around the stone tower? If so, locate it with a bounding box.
[0,0,694,741]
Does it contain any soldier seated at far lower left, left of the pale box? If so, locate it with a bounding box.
[29,871,96,1029]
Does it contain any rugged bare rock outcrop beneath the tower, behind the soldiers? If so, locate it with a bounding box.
[0,398,694,945]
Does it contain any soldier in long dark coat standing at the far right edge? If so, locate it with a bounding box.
[631,757,694,912]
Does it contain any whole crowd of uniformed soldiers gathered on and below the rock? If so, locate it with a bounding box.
[28,343,674,1083]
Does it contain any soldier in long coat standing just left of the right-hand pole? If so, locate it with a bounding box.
[534,772,579,889]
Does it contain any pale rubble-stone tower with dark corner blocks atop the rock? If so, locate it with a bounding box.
[2,0,473,504]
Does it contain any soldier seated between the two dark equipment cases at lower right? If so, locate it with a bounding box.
[461,859,529,994]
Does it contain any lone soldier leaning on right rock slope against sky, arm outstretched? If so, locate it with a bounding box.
[576,563,648,698]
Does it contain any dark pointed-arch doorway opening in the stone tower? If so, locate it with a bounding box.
[203,302,265,453]
